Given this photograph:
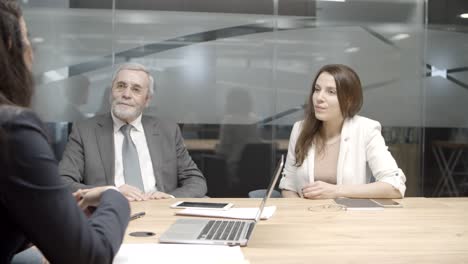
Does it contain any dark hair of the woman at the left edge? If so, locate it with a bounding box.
[0,0,33,107]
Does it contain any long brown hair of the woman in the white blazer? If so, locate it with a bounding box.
[294,64,363,166]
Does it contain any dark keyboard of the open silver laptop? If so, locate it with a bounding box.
[197,220,246,241]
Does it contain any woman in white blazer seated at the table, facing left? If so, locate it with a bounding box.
[280,64,406,199]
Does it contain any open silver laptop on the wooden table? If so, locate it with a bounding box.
[159,155,284,246]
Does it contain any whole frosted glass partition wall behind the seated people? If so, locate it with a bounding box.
[23,0,468,197]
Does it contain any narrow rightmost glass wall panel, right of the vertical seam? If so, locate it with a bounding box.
[422,0,468,196]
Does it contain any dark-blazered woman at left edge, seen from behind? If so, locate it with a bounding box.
[0,0,130,263]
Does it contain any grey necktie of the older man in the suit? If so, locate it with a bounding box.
[120,124,144,191]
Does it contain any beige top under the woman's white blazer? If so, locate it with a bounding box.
[314,137,341,184]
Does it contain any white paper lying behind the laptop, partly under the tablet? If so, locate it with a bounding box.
[176,205,276,220]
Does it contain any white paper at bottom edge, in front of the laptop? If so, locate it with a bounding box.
[114,244,249,264]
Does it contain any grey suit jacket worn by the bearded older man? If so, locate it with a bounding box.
[59,113,207,197]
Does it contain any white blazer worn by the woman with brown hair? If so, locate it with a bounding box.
[280,116,406,197]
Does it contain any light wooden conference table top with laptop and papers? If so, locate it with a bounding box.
[124,198,468,264]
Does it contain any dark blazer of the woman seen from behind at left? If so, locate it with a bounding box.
[0,106,130,263]
